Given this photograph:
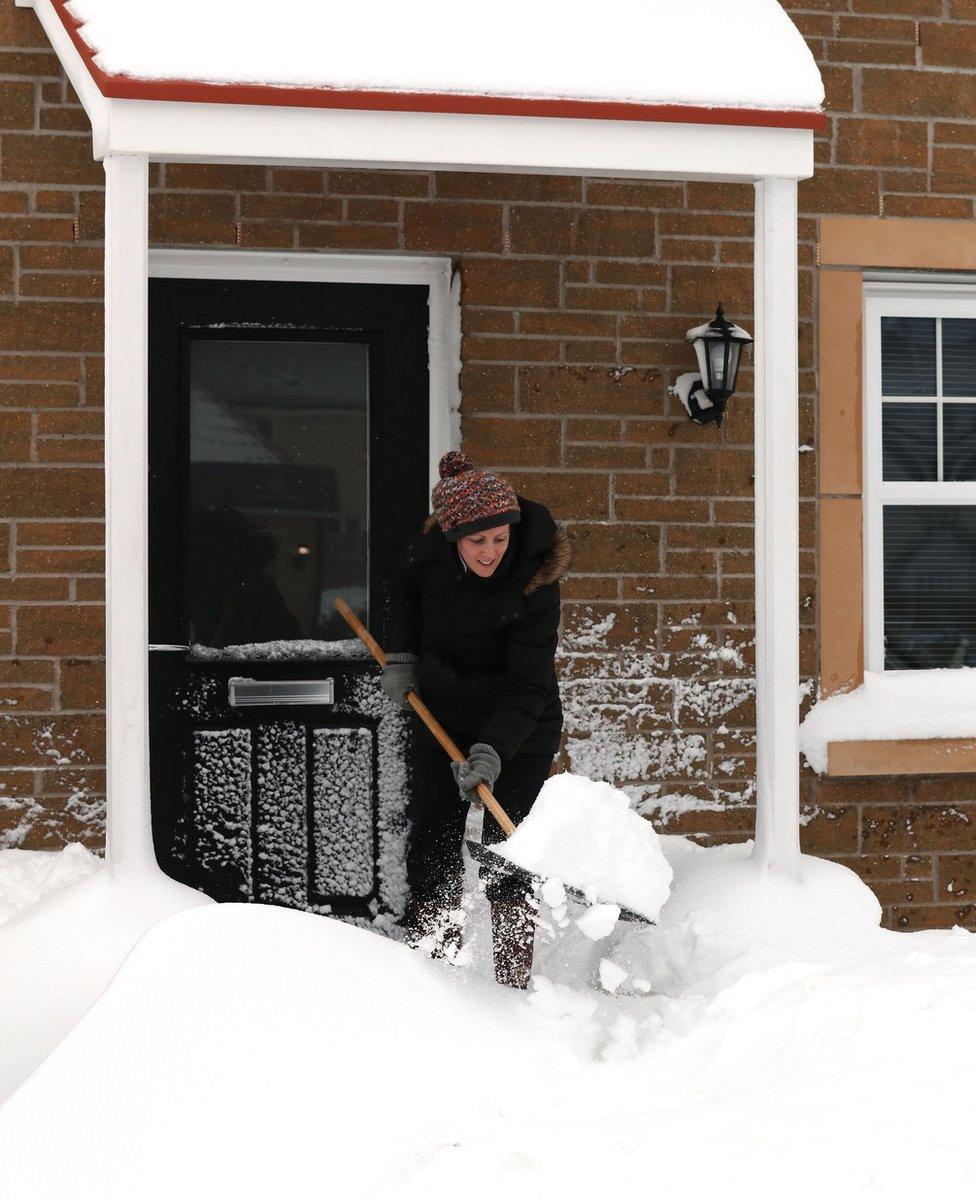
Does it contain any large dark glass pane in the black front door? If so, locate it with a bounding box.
[184,338,369,647]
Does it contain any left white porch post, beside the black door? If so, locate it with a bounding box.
[104,154,155,875]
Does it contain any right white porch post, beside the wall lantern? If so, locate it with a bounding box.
[754,178,800,878]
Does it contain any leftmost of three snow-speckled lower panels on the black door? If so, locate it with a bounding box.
[193,730,252,900]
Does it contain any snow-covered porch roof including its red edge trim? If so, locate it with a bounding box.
[59,0,824,127]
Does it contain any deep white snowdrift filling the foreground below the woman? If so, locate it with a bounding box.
[0,838,976,1200]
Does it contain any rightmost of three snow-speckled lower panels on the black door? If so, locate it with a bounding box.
[312,727,375,896]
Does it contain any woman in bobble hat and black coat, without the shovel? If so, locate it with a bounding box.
[383,451,571,988]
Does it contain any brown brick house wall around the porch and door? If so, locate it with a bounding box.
[0,0,976,928]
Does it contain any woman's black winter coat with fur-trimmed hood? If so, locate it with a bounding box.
[387,496,571,762]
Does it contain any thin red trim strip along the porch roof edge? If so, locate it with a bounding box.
[52,0,827,130]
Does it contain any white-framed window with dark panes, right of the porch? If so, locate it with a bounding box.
[863,280,976,671]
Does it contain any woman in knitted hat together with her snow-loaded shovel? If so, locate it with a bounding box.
[355,451,670,988]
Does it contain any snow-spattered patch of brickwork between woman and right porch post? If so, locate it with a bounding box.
[557,610,755,824]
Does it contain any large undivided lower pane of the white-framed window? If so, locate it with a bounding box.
[884,504,976,671]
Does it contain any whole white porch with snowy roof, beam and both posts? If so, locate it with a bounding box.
[17,0,824,877]
